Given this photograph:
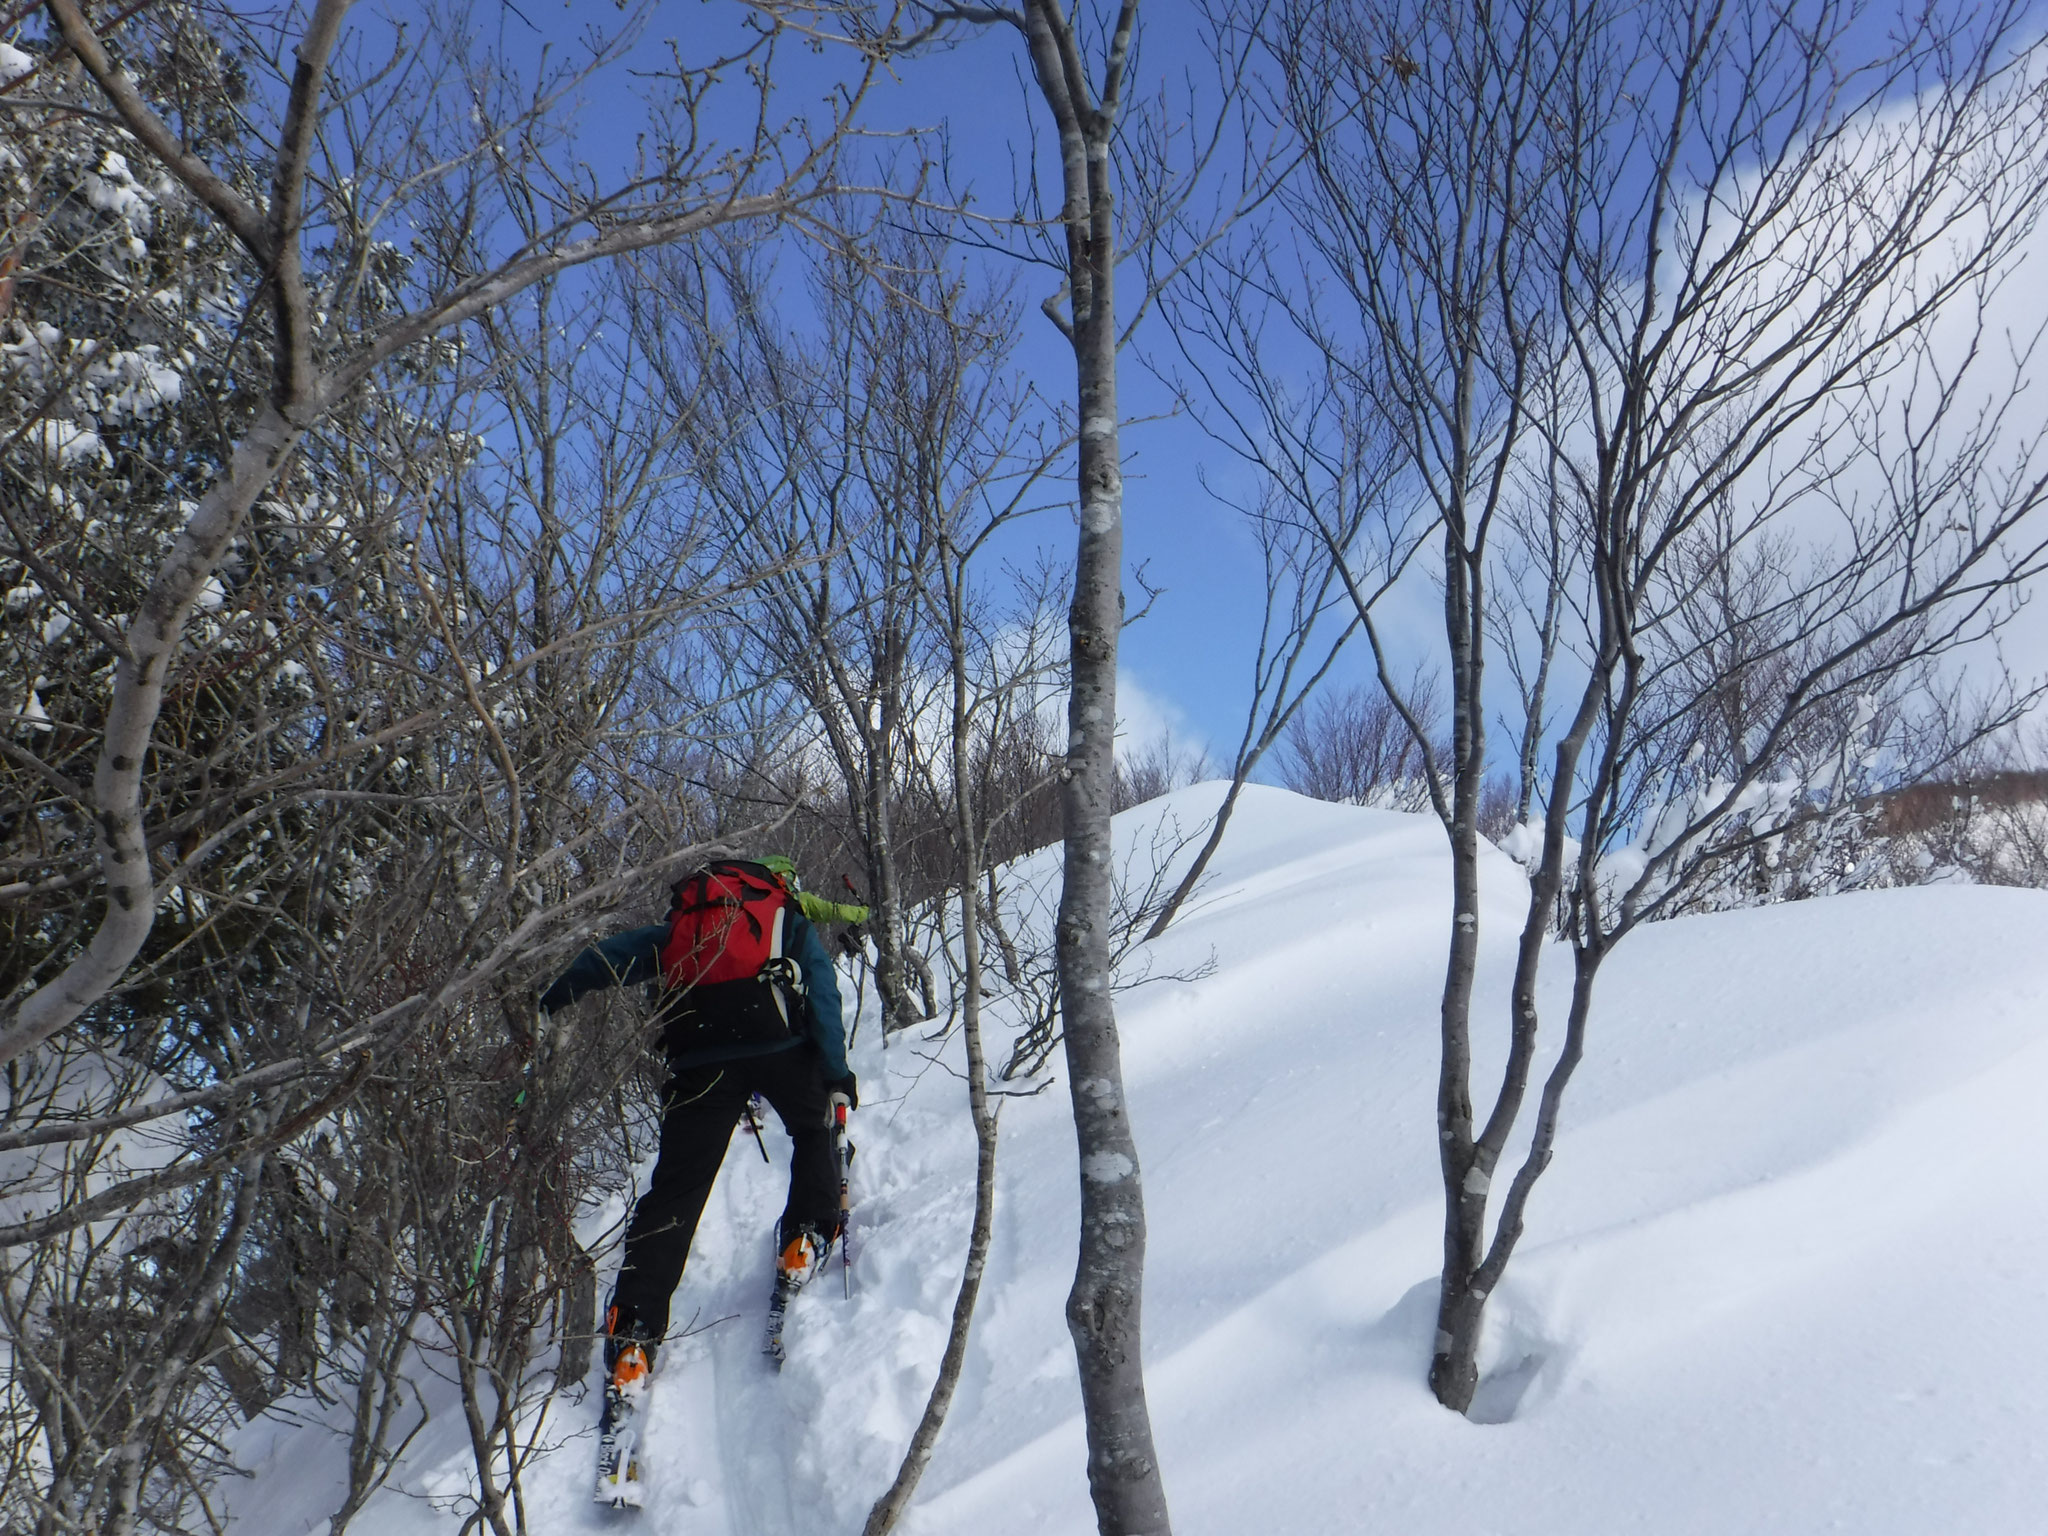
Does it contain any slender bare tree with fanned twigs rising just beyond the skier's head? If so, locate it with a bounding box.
[637,225,981,1030]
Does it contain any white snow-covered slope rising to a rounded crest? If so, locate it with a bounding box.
[233,786,2048,1536]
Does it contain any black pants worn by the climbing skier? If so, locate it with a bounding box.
[612,1047,840,1343]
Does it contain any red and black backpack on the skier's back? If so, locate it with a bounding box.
[662,860,803,1051]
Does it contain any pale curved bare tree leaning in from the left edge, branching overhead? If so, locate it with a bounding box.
[0,0,905,1059]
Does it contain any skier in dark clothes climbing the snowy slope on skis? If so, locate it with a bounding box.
[539,856,868,1503]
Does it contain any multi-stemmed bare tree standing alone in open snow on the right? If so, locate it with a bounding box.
[1272,0,2048,1411]
